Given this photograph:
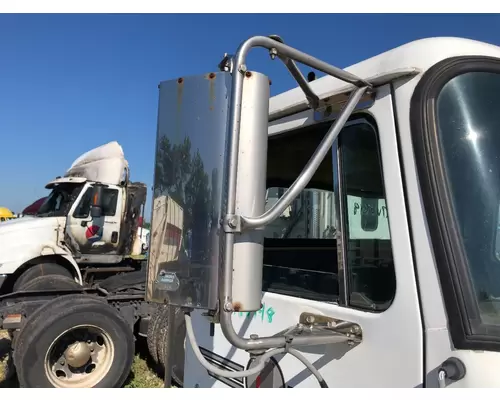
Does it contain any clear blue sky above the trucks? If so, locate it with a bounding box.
[0,14,500,216]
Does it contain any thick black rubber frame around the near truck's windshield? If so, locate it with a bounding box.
[410,56,500,351]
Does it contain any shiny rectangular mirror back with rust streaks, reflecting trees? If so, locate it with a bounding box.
[147,72,231,309]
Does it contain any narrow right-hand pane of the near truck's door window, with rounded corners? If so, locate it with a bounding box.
[340,125,396,311]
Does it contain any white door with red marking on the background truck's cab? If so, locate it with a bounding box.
[67,185,123,254]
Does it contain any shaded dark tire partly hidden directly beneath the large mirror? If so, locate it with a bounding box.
[156,307,186,386]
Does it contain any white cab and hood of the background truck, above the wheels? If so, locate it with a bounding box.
[0,142,147,293]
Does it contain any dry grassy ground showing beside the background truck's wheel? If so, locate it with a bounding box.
[0,331,163,388]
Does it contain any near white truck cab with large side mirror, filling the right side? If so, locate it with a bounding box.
[148,36,500,388]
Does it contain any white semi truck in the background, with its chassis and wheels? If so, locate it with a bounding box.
[0,142,184,387]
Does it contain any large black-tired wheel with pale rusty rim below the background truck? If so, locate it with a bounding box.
[14,295,134,388]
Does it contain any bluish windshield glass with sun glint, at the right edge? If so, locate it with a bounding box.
[436,72,500,325]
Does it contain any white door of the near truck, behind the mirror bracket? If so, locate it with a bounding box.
[184,87,424,388]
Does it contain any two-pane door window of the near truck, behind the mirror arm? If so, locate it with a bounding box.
[263,123,396,311]
